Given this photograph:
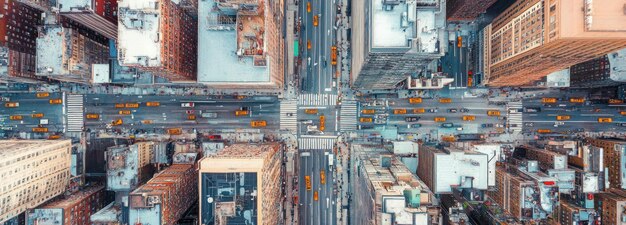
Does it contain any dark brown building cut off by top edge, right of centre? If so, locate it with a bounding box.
[446,0,497,20]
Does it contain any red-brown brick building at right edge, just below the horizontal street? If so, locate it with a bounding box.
[585,138,626,189]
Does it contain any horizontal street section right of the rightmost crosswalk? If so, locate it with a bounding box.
[523,96,626,133]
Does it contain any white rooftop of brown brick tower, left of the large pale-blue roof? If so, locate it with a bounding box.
[118,0,161,67]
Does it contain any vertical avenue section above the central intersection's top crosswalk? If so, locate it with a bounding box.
[300,0,337,94]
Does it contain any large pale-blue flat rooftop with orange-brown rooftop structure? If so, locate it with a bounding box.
[198,0,270,84]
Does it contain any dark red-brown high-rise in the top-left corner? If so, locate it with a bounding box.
[0,0,41,78]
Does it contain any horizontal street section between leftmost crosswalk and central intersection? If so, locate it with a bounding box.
[85,95,280,130]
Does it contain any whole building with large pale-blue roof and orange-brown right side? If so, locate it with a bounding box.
[197,0,285,89]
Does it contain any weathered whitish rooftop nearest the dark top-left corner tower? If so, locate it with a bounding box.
[36,26,71,76]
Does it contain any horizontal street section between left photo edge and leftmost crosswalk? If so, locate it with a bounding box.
[0,93,64,132]
